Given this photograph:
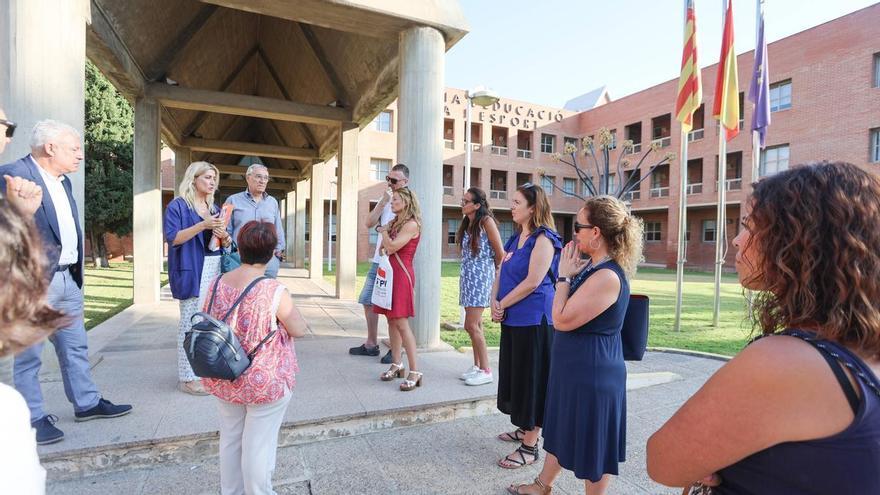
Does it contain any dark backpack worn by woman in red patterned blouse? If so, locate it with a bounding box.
[183,275,276,381]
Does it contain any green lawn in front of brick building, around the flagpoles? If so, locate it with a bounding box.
[324,262,750,355]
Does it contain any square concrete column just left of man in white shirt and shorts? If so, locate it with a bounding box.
[336,123,358,300]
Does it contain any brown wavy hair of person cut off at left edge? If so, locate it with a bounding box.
[0,196,66,356]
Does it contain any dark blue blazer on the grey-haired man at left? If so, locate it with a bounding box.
[0,155,83,288]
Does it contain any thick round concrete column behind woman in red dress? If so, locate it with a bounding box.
[397,27,446,348]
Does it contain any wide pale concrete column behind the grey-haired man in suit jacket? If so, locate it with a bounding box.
[0,0,90,221]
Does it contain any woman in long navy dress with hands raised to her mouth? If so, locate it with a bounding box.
[508,196,643,494]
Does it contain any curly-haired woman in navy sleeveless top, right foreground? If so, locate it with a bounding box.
[647,162,880,495]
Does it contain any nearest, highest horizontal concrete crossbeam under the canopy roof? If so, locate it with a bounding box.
[147,83,351,125]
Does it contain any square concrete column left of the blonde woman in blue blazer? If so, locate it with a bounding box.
[132,98,162,304]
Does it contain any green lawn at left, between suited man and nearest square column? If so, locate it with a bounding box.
[85,262,168,329]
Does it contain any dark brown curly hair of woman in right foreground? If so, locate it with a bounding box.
[741,162,880,357]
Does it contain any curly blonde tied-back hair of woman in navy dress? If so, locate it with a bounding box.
[584,196,644,278]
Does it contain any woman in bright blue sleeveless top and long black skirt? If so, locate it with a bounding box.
[491,184,562,469]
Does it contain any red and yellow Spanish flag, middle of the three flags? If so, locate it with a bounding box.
[712,0,739,141]
